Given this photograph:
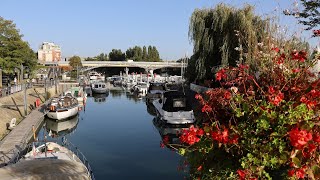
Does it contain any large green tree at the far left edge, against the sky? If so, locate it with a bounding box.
[0,17,37,74]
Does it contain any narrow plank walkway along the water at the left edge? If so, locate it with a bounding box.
[0,105,45,167]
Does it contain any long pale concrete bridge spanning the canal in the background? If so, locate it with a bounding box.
[44,61,187,71]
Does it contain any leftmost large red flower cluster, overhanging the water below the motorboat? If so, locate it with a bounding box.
[179,125,204,145]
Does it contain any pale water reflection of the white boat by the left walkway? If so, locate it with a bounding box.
[46,116,79,137]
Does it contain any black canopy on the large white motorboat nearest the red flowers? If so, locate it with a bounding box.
[163,91,192,112]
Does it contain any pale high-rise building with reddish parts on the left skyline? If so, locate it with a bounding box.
[38,42,61,62]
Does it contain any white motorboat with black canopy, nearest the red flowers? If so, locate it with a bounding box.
[152,91,195,124]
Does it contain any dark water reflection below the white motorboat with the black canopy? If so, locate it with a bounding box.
[153,118,191,149]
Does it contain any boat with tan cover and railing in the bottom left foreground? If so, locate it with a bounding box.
[0,142,95,180]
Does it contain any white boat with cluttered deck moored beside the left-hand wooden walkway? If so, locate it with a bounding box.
[47,95,79,120]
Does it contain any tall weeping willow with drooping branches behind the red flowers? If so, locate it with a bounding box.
[187,4,269,81]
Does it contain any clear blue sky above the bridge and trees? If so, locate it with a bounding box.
[0,0,310,60]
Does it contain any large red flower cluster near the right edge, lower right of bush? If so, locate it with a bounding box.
[289,127,312,149]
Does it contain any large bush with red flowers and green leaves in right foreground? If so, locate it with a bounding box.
[164,48,320,179]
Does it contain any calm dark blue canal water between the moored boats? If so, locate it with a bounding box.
[39,91,187,180]
